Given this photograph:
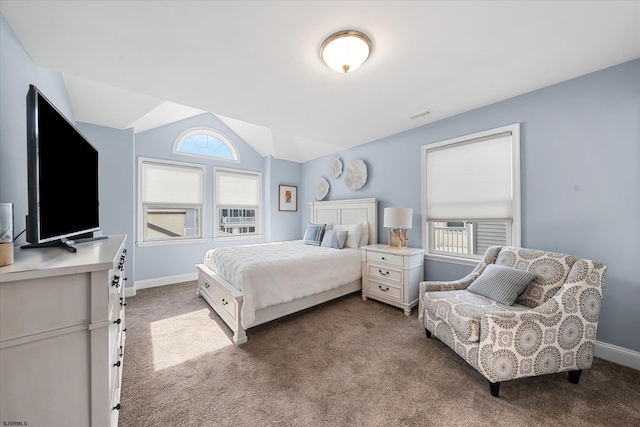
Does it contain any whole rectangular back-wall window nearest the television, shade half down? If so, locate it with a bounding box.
[138,157,206,246]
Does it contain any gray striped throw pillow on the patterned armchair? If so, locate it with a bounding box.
[467,264,535,305]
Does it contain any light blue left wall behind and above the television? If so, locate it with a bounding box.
[0,14,75,246]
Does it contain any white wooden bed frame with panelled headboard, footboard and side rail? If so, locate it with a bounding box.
[196,199,378,345]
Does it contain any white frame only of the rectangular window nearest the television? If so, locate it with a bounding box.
[136,156,207,247]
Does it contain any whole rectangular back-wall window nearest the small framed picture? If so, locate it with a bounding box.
[213,168,262,238]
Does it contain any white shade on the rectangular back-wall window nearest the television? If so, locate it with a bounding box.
[142,162,204,205]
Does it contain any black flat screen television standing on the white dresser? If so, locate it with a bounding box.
[23,85,100,252]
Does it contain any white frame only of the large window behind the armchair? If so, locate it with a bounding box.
[420,123,522,266]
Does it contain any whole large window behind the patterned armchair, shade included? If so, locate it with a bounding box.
[422,124,520,265]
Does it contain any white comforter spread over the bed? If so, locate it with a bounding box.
[204,240,362,329]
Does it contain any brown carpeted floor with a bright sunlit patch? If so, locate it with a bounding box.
[120,282,640,427]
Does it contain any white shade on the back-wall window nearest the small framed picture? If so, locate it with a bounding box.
[215,170,260,208]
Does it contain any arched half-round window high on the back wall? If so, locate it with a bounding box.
[173,128,240,163]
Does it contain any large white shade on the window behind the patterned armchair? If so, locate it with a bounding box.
[425,132,513,221]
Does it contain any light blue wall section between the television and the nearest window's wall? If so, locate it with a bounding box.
[77,122,136,288]
